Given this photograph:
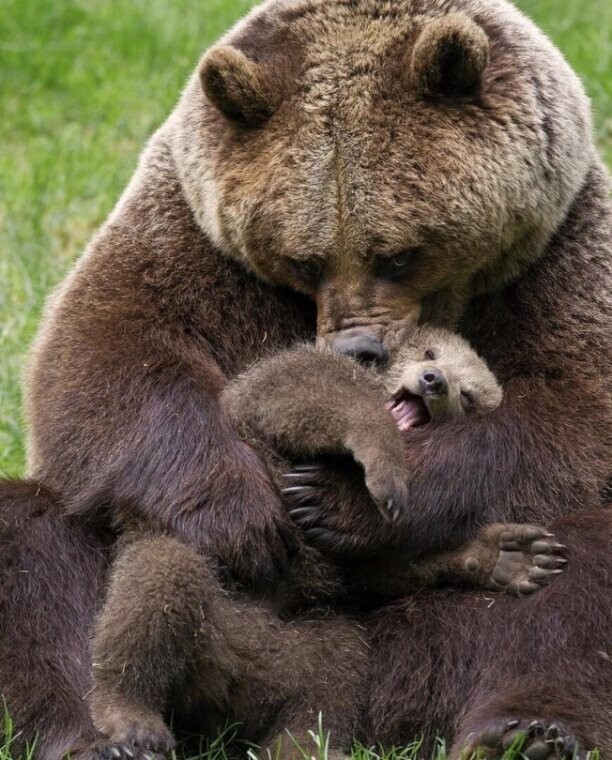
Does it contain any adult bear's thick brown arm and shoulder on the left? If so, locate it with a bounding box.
[26,146,312,585]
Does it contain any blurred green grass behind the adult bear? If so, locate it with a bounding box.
[0,0,612,475]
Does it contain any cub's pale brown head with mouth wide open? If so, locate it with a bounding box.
[385,326,502,430]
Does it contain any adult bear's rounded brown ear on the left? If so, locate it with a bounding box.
[199,45,280,127]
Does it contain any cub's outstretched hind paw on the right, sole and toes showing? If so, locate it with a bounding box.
[491,524,567,595]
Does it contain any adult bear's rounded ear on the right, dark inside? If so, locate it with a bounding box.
[412,13,489,99]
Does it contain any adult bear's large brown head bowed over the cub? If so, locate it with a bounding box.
[171,0,593,360]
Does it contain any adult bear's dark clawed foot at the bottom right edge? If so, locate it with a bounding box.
[460,718,586,760]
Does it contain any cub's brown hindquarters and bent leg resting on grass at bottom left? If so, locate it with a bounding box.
[90,536,367,760]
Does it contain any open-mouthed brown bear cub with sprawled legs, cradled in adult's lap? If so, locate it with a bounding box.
[88,327,566,760]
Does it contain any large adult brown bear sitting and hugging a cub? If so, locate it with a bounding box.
[0,0,612,758]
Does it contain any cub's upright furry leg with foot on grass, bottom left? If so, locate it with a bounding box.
[89,535,225,757]
